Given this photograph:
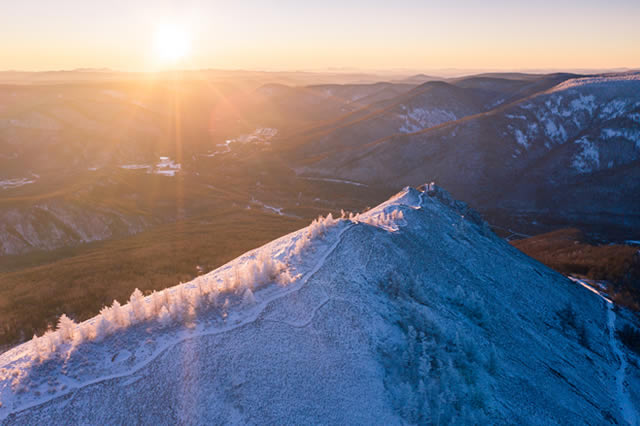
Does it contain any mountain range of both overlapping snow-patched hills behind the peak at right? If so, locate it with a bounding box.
[291,73,640,236]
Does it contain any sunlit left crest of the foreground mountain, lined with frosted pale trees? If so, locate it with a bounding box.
[0,188,421,419]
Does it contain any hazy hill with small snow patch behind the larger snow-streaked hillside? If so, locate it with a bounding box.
[284,74,572,158]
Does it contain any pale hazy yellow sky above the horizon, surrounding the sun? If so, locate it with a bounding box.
[0,0,640,70]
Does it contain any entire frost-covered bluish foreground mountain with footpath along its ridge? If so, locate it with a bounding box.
[0,186,639,424]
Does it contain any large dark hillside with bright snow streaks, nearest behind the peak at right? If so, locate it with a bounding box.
[299,73,640,239]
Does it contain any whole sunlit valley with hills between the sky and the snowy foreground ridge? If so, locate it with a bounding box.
[0,68,640,392]
